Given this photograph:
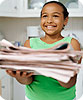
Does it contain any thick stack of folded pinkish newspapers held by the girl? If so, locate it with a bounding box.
[0,39,83,83]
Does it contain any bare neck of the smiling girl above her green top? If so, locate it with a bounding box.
[41,34,63,44]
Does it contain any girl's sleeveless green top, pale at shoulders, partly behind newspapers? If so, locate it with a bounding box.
[25,37,76,100]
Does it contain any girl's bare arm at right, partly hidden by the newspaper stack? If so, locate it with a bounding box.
[58,39,82,88]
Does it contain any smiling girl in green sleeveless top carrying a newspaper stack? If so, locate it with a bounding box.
[7,1,80,100]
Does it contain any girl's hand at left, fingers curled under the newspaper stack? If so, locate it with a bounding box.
[6,70,33,85]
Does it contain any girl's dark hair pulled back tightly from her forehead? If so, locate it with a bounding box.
[41,1,69,19]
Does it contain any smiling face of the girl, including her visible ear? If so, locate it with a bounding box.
[41,3,68,35]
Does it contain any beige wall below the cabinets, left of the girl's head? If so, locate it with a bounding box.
[0,18,40,43]
